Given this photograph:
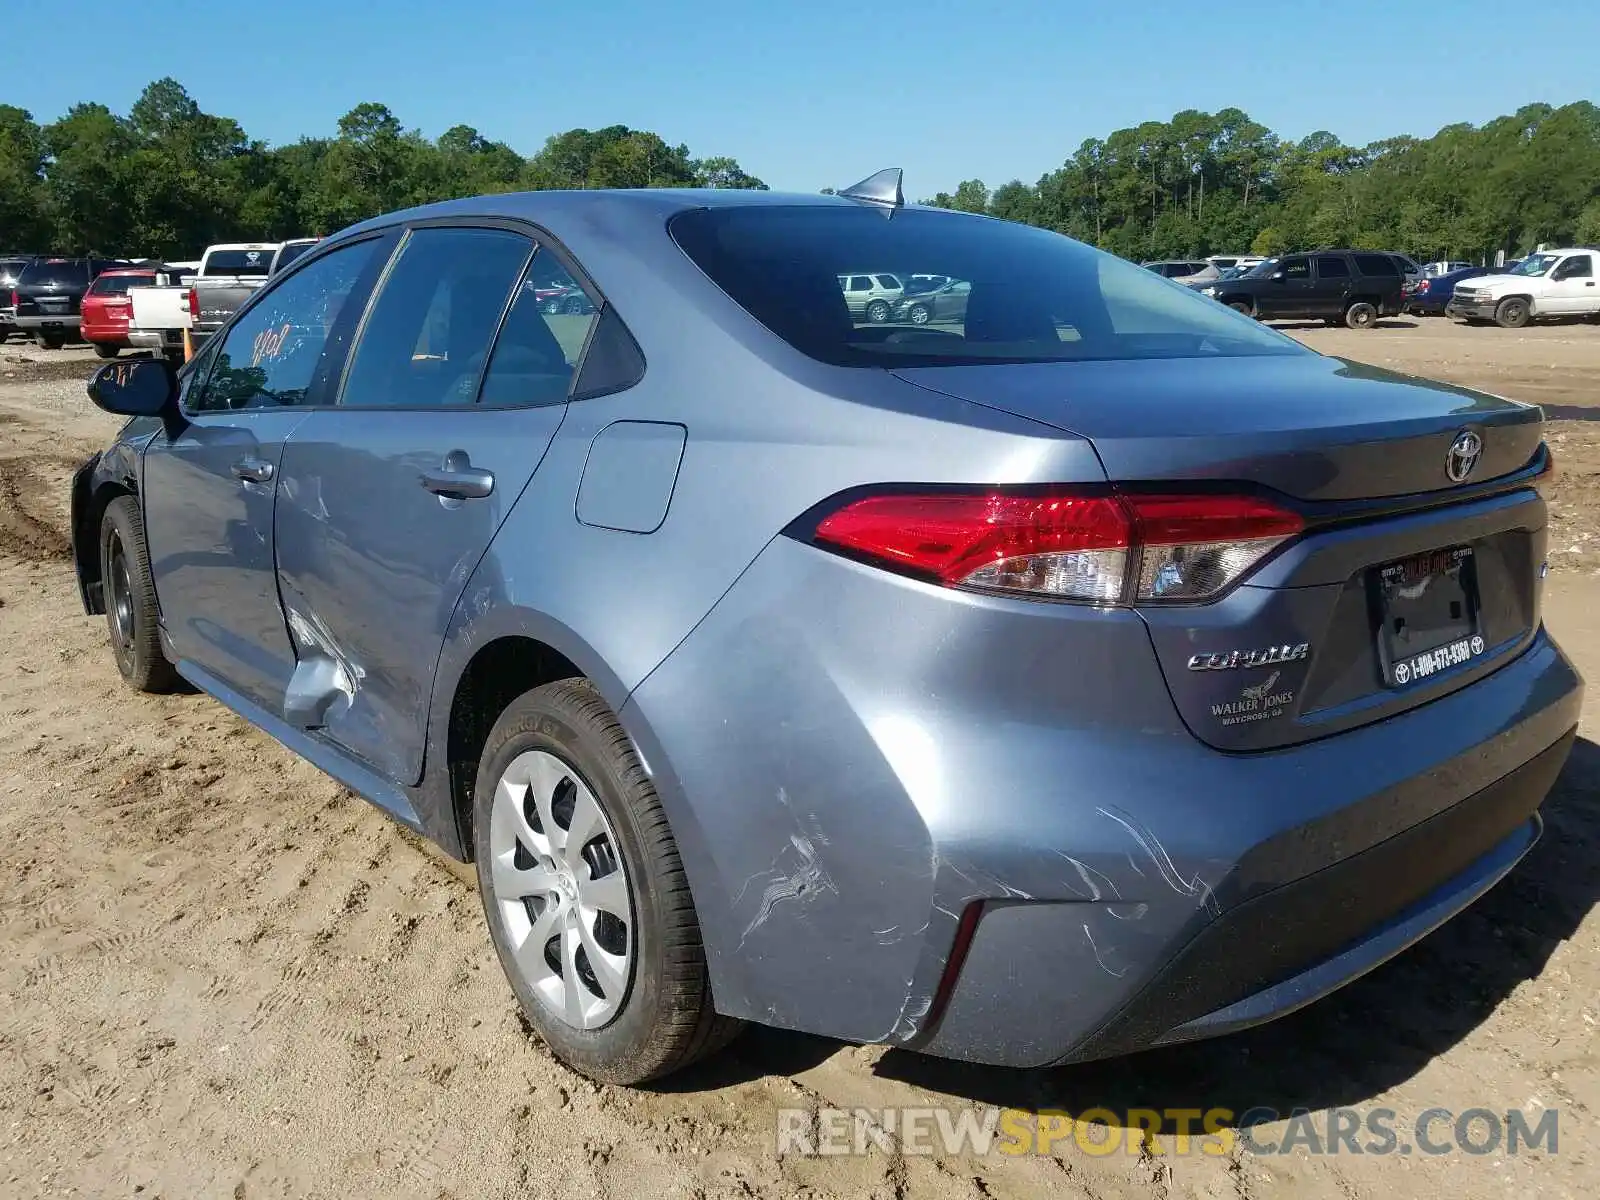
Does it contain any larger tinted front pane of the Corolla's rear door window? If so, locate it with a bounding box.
[340,229,533,408]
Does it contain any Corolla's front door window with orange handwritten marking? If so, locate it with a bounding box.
[192,240,378,411]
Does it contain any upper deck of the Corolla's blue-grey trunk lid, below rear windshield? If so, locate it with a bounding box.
[896,354,1542,501]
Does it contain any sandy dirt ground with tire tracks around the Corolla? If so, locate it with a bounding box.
[0,320,1600,1200]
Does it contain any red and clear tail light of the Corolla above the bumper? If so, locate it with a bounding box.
[813,488,1304,605]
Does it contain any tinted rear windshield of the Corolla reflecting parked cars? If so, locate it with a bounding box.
[670,205,1309,368]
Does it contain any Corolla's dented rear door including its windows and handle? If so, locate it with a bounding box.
[275,222,594,784]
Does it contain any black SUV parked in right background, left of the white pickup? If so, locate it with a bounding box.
[1200,250,1405,330]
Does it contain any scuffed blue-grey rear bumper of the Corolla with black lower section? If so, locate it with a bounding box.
[622,538,1582,1067]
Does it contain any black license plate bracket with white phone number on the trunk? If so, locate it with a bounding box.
[1371,546,1485,688]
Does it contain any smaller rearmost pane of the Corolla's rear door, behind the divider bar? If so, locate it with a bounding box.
[478,250,597,408]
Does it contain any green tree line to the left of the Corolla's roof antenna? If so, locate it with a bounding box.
[0,78,765,258]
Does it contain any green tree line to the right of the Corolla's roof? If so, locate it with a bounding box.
[931,101,1600,261]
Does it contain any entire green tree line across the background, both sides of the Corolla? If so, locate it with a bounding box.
[0,78,1600,259]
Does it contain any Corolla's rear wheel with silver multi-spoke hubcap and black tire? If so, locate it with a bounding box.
[472,678,744,1085]
